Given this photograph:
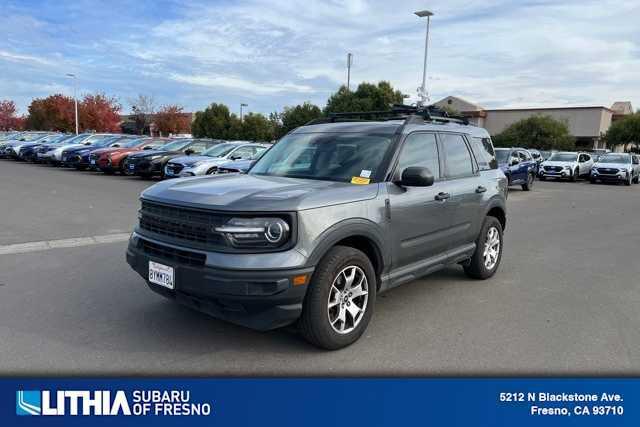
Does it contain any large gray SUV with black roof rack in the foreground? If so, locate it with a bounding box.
[127,106,507,349]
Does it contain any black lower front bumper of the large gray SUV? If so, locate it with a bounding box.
[127,233,314,331]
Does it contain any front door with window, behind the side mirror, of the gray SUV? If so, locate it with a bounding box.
[387,132,454,269]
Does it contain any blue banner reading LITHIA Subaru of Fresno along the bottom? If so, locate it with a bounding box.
[0,378,640,427]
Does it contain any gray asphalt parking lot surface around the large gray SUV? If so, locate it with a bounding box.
[0,160,640,375]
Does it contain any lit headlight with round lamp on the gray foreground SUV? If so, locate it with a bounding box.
[215,218,290,248]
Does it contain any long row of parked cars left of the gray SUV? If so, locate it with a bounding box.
[0,132,271,178]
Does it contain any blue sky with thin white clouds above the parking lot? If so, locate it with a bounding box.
[0,0,640,113]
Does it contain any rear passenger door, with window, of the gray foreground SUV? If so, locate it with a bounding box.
[438,133,486,250]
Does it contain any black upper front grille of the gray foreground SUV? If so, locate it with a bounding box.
[140,201,230,247]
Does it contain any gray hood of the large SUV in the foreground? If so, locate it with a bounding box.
[142,174,378,212]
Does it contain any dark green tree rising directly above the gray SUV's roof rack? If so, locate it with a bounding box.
[324,81,404,113]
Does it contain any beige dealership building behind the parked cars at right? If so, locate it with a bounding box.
[435,96,633,149]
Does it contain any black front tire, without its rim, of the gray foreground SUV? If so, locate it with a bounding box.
[298,246,377,350]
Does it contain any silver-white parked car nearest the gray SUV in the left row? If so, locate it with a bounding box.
[164,142,270,178]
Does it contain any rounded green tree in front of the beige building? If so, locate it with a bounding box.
[492,116,575,150]
